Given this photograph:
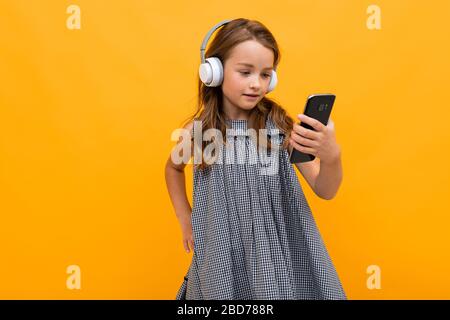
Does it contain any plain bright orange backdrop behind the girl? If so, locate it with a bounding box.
[0,0,450,299]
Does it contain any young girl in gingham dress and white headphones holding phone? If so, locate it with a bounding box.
[165,19,347,300]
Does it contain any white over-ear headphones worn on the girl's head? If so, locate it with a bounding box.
[198,20,278,93]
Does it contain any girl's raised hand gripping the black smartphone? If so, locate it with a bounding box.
[289,114,341,163]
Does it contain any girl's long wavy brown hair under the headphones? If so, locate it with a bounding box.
[181,18,293,169]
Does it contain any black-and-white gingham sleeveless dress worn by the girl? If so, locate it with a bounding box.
[176,118,347,300]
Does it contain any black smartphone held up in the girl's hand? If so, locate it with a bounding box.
[289,93,336,163]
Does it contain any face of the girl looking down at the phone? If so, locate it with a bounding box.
[222,40,274,118]
